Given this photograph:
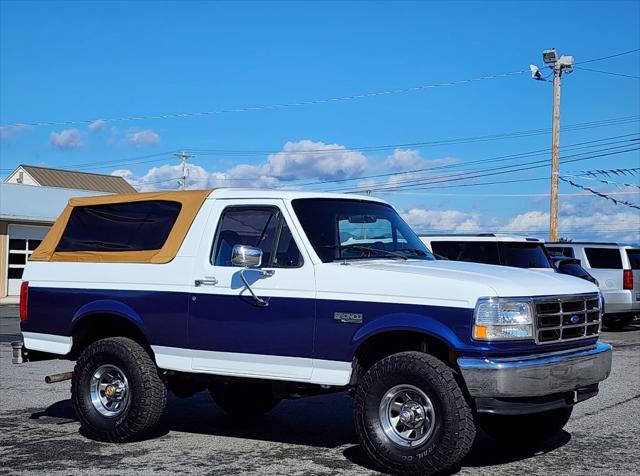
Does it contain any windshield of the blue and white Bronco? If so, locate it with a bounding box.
[293,198,435,263]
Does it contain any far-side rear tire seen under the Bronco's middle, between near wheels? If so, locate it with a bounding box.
[209,383,280,419]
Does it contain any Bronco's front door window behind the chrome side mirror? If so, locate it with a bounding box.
[211,207,302,268]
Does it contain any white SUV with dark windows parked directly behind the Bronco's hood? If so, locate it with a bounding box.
[420,233,555,272]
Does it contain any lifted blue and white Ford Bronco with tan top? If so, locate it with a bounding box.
[20,189,611,474]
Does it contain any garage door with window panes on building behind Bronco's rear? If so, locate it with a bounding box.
[7,225,49,296]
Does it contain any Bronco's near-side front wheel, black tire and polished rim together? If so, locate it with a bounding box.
[355,352,475,475]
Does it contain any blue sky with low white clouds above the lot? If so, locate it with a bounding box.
[0,1,640,242]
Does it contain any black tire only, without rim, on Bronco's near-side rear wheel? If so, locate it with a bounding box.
[71,337,167,443]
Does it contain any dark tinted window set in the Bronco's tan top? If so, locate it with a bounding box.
[56,200,182,252]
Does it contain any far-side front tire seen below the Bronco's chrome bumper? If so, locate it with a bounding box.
[478,407,573,444]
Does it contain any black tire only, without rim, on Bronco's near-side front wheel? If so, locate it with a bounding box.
[355,352,476,475]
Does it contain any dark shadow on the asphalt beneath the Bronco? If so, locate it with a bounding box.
[30,392,571,474]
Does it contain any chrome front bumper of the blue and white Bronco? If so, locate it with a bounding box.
[458,342,611,398]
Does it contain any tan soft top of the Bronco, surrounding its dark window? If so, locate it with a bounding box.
[29,190,212,263]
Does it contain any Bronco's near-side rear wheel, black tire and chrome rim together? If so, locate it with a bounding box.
[71,337,167,442]
